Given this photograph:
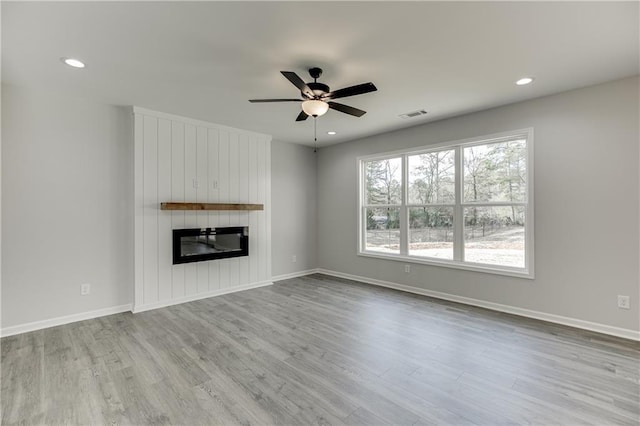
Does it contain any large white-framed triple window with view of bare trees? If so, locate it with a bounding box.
[359,129,533,277]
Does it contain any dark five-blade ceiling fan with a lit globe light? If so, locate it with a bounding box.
[249,67,378,121]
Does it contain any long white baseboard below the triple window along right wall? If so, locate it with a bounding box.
[316,268,640,341]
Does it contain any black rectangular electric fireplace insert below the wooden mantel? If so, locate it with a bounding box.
[173,226,249,265]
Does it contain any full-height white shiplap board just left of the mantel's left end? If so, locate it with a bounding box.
[143,117,160,304]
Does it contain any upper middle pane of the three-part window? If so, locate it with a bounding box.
[409,150,456,204]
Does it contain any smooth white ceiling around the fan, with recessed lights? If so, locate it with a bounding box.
[2,1,640,146]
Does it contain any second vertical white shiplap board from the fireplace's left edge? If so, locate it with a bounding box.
[184,124,198,296]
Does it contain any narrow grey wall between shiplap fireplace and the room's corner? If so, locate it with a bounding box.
[271,141,317,280]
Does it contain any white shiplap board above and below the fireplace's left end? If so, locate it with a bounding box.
[170,121,186,298]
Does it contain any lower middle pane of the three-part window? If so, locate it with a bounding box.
[409,207,453,260]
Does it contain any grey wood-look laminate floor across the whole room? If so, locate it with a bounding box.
[0,275,640,425]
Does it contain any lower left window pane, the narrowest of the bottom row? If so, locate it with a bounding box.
[365,208,400,254]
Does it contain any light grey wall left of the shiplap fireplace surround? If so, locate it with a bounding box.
[2,85,133,335]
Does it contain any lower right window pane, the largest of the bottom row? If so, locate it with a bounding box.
[464,206,525,268]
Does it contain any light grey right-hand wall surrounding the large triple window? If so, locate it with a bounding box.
[318,77,640,336]
